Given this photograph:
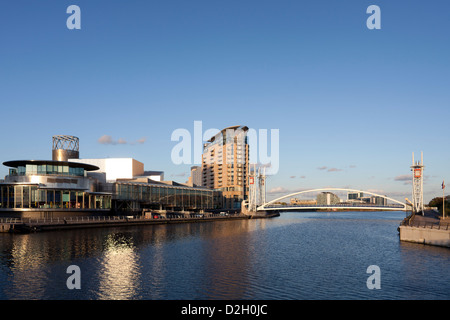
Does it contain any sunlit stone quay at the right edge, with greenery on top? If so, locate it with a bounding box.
[398,211,450,248]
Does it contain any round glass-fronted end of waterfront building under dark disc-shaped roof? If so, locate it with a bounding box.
[0,160,112,217]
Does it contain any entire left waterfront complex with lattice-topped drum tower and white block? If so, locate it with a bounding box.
[0,135,223,218]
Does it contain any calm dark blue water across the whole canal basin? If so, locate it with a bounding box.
[0,212,450,300]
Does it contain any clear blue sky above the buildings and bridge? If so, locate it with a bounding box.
[0,0,450,201]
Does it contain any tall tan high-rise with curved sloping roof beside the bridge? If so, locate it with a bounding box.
[202,126,249,209]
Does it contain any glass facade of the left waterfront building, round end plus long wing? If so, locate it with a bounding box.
[0,160,223,214]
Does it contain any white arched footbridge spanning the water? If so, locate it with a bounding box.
[256,188,411,211]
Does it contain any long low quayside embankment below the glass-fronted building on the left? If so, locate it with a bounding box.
[0,214,276,233]
